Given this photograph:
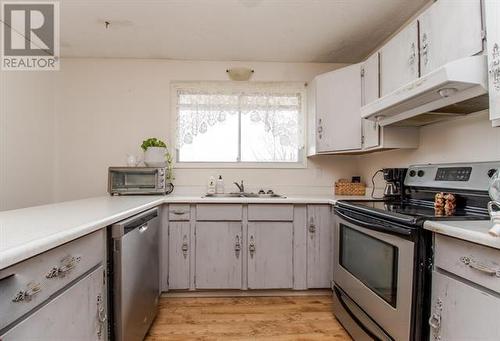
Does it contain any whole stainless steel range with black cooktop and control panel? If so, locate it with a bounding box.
[333,162,500,340]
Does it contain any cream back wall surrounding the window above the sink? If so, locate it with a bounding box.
[56,59,356,200]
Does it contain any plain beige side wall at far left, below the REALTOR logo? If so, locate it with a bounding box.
[0,71,55,211]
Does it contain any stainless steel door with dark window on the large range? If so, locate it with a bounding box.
[333,207,415,340]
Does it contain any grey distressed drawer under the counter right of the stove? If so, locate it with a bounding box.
[435,234,500,293]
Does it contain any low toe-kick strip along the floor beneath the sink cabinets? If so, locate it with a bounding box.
[161,289,332,297]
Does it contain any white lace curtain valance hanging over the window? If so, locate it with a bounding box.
[174,82,305,149]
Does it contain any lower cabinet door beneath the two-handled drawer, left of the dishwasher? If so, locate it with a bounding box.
[0,266,107,341]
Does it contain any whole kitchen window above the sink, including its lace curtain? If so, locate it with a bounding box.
[173,82,305,168]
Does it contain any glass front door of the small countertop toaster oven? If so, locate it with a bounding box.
[109,168,159,193]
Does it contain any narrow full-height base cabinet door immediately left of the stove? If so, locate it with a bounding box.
[307,205,333,288]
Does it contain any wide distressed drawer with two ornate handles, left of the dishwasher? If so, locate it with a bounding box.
[0,230,105,329]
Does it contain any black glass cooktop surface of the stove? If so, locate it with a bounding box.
[338,200,489,223]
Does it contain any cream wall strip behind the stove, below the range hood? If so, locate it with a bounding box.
[358,111,500,187]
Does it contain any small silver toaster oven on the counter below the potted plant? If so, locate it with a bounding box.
[108,167,174,195]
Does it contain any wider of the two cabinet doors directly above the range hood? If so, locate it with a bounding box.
[418,0,483,76]
